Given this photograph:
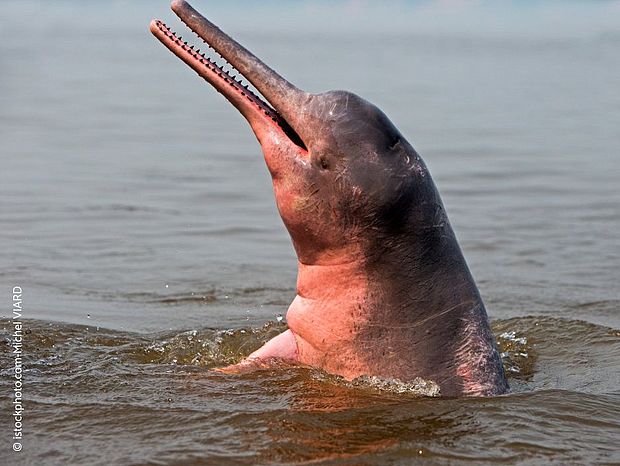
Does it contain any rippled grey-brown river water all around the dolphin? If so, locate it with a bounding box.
[0,1,620,465]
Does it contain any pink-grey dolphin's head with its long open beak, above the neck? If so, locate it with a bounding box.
[150,0,441,265]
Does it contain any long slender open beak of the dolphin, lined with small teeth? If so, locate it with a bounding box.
[150,1,306,150]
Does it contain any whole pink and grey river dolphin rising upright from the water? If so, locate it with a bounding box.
[150,1,507,395]
